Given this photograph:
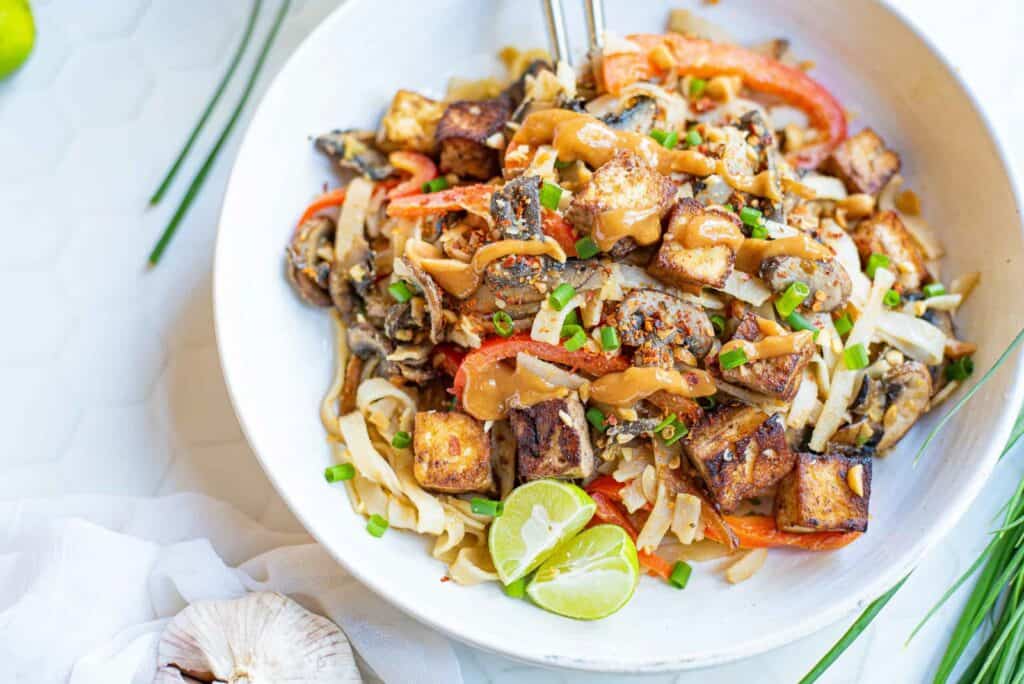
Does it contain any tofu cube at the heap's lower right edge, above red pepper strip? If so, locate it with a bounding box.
[775,454,871,532]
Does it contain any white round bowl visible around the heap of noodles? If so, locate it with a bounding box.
[214,0,1024,672]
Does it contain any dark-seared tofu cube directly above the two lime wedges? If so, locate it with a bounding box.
[509,394,594,481]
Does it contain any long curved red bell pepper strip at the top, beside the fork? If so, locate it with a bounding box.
[601,34,846,169]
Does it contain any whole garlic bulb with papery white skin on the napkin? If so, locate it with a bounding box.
[155,592,362,684]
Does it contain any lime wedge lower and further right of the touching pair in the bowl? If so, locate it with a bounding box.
[526,525,640,619]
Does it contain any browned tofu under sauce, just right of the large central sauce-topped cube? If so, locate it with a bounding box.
[647,199,739,288]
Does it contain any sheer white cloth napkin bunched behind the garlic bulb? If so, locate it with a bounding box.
[0,494,463,684]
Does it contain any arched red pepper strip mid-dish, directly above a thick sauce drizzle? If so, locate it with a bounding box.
[452,333,630,397]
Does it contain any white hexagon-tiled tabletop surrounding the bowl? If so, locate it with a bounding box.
[0,0,1024,682]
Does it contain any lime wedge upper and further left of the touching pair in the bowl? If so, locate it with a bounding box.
[487,480,597,585]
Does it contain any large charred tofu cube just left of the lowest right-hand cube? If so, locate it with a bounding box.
[683,403,796,512]
